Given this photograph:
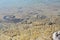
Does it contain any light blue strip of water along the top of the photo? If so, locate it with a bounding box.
[0,0,60,8]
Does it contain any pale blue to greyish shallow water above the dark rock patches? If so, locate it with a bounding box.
[0,0,60,17]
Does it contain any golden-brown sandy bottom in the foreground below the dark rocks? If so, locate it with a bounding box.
[0,15,60,40]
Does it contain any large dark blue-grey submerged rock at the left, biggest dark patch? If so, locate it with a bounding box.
[3,15,24,23]
